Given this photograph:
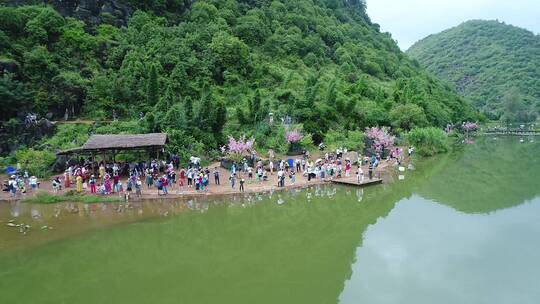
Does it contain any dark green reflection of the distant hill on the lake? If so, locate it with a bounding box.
[414,138,540,213]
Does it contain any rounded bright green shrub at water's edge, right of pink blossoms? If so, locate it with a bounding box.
[407,127,448,156]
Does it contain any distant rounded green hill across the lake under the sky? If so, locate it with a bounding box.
[407,20,540,118]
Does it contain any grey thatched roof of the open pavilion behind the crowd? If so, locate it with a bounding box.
[57,133,167,155]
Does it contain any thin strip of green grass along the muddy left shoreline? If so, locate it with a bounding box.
[21,191,121,204]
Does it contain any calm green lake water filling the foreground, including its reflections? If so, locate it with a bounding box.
[0,138,540,304]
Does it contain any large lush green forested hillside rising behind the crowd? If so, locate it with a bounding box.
[0,0,476,156]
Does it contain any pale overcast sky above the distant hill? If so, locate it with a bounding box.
[367,0,540,50]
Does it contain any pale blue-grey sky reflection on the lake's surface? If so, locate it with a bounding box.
[339,196,540,304]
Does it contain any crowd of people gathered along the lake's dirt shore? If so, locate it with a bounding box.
[4,147,413,197]
